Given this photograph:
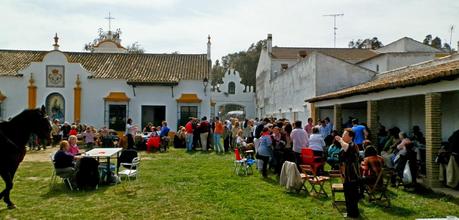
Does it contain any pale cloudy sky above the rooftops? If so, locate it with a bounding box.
[0,0,459,60]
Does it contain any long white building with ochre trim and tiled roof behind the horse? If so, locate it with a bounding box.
[0,32,211,131]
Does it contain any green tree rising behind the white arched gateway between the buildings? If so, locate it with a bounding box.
[212,40,266,88]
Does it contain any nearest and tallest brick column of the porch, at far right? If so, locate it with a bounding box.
[425,93,441,188]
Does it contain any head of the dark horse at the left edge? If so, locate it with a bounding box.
[28,106,51,138]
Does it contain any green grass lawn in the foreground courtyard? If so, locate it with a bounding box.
[0,149,459,219]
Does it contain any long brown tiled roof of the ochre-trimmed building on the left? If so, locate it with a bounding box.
[0,50,210,84]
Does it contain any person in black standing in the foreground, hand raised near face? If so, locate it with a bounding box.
[335,128,360,218]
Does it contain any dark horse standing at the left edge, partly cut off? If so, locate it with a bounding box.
[0,106,51,209]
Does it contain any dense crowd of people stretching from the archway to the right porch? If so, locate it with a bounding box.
[174,117,425,217]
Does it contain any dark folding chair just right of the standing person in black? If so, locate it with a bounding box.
[365,169,393,207]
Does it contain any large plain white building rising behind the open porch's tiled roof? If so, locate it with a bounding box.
[256,34,444,122]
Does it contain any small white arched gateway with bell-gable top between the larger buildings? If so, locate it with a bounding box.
[212,69,255,118]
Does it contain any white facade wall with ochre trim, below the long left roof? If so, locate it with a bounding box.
[0,51,210,130]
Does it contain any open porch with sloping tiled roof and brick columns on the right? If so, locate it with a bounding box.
[306,54,459,187]
